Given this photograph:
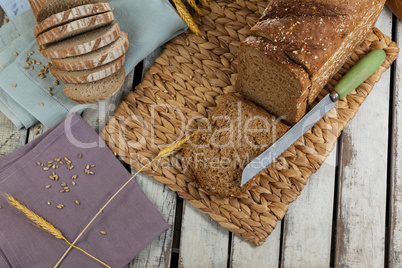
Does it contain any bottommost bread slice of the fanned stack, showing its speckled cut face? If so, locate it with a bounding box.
[64,68,126,103]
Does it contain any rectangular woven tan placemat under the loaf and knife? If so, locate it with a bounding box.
[102,0,399,246]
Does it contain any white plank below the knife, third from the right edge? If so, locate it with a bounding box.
[282,149,337,267]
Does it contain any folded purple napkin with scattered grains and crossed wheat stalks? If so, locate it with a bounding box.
[0,114,168,268]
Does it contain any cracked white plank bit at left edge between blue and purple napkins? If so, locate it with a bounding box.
[0,113,28,157]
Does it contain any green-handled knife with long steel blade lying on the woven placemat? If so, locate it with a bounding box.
[241,49,386,186]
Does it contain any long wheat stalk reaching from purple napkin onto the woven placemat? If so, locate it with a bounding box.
[54,132,197,268]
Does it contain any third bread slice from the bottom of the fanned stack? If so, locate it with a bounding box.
[52,32,129,71]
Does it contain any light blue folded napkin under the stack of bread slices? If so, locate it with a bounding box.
[0,0,187,128]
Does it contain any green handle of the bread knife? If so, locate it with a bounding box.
[334,49,386,99]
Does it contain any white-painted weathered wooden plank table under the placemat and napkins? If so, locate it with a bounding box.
[0,4,402,268]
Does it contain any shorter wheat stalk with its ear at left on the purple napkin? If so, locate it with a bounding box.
[4,194,110,268]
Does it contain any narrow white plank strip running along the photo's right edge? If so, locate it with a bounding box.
[389,17,402,267]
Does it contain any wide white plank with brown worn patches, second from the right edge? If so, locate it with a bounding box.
[335,9,392,267]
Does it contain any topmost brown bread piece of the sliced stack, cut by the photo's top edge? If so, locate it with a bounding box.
[29,0,107,23]
